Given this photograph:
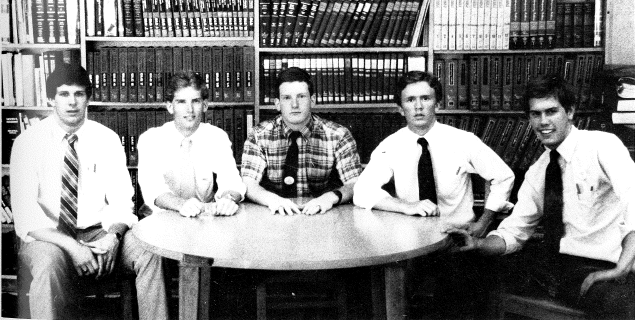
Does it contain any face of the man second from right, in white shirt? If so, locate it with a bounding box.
[399,81,438,135]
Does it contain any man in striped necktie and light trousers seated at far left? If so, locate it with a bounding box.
[11,64,168,319]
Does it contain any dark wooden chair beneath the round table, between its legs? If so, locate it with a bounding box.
[256,271,347,320]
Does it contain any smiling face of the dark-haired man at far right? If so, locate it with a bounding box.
[529,97,574,149]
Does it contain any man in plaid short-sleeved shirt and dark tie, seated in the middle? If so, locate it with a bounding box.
[242,67,361,215]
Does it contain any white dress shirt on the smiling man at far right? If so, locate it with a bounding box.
[490,127,635,262]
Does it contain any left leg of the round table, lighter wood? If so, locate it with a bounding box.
[179,255,213,320]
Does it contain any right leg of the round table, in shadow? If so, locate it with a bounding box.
[384,262,407,320]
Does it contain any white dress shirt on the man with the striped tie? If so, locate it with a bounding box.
[11,116,137,242]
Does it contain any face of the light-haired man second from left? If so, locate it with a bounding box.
[168,86,207,136]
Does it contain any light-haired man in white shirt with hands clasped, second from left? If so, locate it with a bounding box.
[137,72,245,217]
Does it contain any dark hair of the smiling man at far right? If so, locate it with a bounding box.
[523,73,576,113]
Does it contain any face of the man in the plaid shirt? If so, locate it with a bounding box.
[275,81,315,129]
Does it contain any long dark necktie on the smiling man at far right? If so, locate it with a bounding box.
[543,150,565,254]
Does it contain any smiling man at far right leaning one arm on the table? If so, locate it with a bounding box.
[451,75,635,319]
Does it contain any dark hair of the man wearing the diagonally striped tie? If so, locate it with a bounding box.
[46,62,93,99]
